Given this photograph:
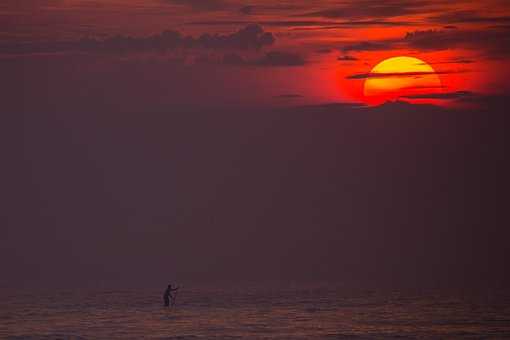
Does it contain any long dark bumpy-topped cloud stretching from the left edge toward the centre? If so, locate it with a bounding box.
[0,24,275,54]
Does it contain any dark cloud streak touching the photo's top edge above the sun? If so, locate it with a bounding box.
[299,0,430,20]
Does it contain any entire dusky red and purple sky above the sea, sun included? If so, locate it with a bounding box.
[0,0,510,287]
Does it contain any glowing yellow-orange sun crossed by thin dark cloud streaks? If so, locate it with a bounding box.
[363,56,442,104]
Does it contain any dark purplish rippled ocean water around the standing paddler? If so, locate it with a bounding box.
[0,286,510,339]
